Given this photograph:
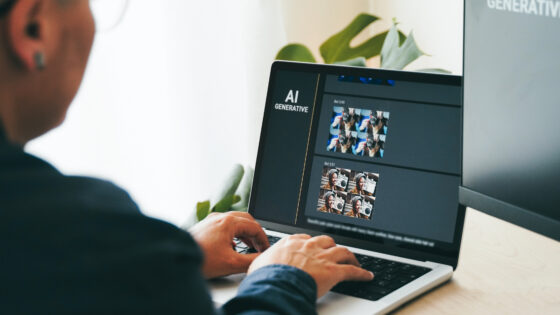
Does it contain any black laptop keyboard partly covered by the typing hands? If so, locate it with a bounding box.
[235,235,431,301]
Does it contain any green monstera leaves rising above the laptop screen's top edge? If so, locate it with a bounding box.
[276,13,449,73]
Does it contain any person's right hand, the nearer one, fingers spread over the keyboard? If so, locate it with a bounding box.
[248,234,373,298]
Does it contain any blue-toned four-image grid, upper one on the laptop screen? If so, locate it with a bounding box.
[327,106,389,158]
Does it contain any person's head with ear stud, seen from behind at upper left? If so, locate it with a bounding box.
[0,0,95,145]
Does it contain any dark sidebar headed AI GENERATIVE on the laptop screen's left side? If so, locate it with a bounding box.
[251,71,319,224]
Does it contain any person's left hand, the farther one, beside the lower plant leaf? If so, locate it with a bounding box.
[189,211,269,279]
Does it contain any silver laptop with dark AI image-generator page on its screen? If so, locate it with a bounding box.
[210,61,465,314]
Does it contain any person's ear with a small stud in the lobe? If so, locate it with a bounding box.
[7,0,47,71]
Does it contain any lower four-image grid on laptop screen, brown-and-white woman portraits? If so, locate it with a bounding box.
[317,166,379,220]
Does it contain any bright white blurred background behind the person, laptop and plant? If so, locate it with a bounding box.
[26,0,463,225]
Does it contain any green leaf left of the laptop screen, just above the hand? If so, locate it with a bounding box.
[183,164,254,228]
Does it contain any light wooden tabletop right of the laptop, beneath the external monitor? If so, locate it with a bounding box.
[394,209,560,315]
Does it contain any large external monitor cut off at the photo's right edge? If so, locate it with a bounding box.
[459,0,560,240]
